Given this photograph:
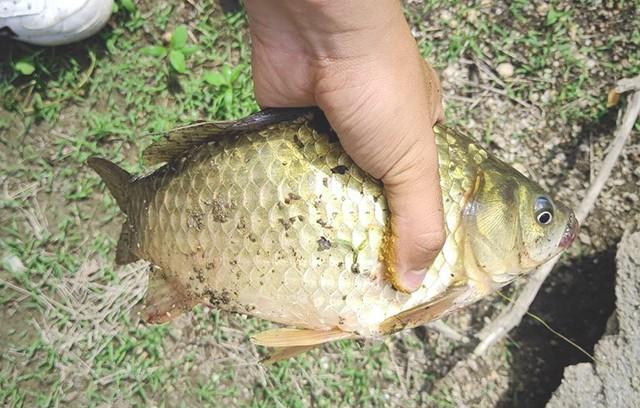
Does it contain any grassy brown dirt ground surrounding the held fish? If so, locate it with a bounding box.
[0,0,640,407]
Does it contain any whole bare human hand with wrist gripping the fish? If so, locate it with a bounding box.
[245,0,445,292]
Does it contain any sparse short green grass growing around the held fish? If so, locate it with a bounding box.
[0,0,640,407]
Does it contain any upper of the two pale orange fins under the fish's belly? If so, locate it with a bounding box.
[251,328,356,347]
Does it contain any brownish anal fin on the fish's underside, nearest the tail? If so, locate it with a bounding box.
[141,266,200,324]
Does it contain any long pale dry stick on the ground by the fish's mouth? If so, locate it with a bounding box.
[473,76,640,355]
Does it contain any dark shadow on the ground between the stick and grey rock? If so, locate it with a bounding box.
[498,246,616,407]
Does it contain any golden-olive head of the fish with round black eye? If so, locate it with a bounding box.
[463,162,579,284]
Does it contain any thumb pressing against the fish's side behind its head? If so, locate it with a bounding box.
[383,130,445,292]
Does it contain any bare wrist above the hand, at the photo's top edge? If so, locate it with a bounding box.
[245,0,413,61]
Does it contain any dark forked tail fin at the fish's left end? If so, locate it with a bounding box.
[87,157,140,265]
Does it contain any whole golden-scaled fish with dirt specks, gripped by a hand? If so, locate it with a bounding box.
[88,108,579,362]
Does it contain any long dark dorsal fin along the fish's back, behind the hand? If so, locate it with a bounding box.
[142,107,318,164]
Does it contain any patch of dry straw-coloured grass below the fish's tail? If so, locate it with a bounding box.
[0,259,147,384]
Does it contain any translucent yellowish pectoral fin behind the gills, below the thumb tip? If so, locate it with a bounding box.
[380,285,469,334]
